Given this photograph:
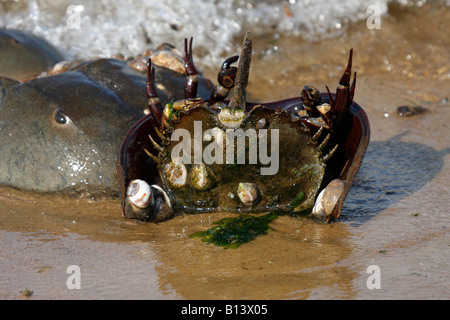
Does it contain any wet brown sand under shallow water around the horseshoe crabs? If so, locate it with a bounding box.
[0,3,450,299]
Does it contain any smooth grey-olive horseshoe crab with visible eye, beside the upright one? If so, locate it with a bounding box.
[0,43,213,197]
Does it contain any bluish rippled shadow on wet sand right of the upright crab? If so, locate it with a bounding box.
[342,131,450,226]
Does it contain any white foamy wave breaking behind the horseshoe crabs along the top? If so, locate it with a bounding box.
[0,0,428,64]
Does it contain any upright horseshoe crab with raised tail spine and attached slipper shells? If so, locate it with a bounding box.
[117,33,370,221]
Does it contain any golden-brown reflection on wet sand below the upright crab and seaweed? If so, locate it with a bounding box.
[153,213,356,299]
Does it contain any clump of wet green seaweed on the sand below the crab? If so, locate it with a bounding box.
[189,211,278,249]
